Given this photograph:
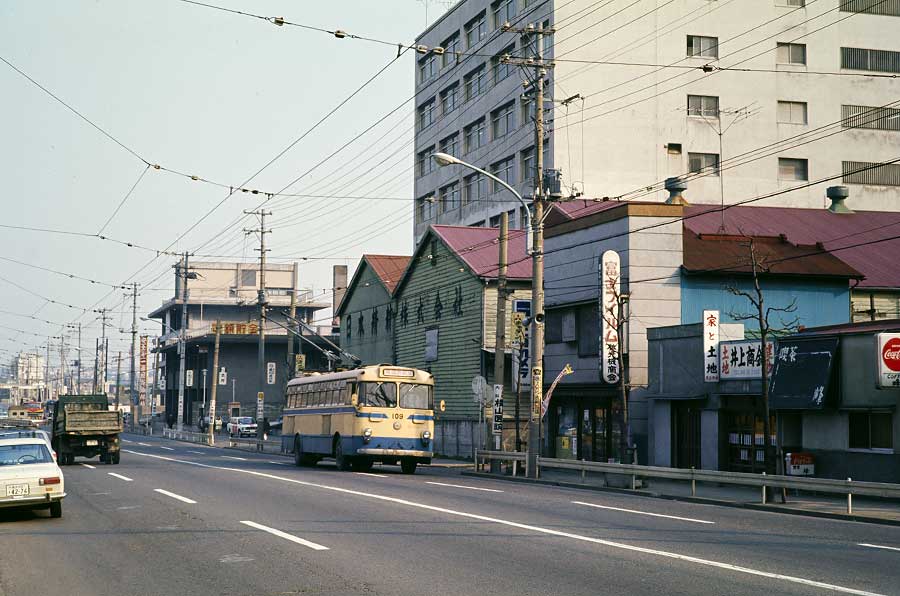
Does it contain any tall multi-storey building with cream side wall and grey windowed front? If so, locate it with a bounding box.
[415,0,900,239]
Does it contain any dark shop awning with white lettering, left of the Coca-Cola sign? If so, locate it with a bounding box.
[769,337,838,410]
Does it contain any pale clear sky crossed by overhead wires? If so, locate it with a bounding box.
[0,0,449,362]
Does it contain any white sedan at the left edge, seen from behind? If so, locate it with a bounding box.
[0,438,66,517]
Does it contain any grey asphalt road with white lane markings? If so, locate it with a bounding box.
[0,436,900,596]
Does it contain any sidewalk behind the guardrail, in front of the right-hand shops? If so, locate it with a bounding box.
[463,469,900,525]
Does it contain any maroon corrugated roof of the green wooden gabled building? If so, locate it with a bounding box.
[431,226,531,280]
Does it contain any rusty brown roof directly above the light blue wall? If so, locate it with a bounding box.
[683,230,862,279]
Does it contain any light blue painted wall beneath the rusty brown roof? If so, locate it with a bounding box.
[681,275,850,332]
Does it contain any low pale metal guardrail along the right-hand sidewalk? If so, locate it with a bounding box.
[475,450,900,514]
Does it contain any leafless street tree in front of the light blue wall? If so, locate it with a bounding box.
[725,237,800,499]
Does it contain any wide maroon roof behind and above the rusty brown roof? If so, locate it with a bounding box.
[684,205,900,288]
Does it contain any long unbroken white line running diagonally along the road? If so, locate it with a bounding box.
[128,450,884,596]
